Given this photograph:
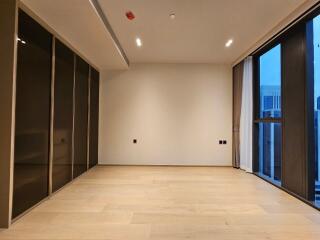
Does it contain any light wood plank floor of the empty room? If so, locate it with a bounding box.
[0,167,320,240]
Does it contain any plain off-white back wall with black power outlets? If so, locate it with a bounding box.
[99,64,232,166]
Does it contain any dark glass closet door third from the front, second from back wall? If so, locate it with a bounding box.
[73,56,89,178]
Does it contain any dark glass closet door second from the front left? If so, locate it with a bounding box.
[52,40,74,191]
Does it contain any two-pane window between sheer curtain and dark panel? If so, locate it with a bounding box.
[256,44,281,184]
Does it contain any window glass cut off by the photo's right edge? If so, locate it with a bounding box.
[307,16,320,207]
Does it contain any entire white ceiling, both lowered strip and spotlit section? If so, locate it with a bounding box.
[22,0,314,67]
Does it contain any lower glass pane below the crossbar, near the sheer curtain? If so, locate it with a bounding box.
[258,123,281,184]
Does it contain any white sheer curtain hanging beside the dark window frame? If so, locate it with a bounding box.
[240,57,253,172]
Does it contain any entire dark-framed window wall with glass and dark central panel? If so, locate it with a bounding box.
[253,6,320,209]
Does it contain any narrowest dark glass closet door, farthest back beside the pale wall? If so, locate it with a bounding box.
[89,68,99,168]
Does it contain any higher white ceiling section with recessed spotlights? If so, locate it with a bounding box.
[99,0,305,63]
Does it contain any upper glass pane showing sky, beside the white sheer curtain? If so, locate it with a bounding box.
[259,44,281,118]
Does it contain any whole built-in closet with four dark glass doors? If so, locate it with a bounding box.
[12,10,99,219]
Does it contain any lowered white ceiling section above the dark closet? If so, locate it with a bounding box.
[22,0,128,70]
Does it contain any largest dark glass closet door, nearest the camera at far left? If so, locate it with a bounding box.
[12,11,52,218]
